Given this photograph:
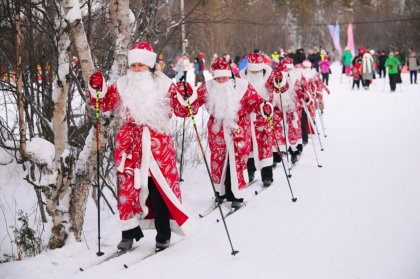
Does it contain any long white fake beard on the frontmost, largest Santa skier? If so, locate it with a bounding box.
[120,71,171,133]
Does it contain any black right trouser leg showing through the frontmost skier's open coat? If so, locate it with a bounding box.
[148,177,171,243]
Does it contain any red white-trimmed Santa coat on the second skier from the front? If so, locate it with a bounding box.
[191,79,264,199]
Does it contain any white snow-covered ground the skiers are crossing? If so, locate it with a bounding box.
[0,65,420,279]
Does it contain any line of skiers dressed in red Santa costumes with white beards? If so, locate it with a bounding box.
[89,42,329,252]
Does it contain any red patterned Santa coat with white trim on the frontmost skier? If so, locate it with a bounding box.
[91,72,191,235]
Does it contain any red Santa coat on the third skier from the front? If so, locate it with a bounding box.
[240,67,274,169]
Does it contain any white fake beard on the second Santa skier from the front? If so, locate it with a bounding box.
[206,80,240,129]
